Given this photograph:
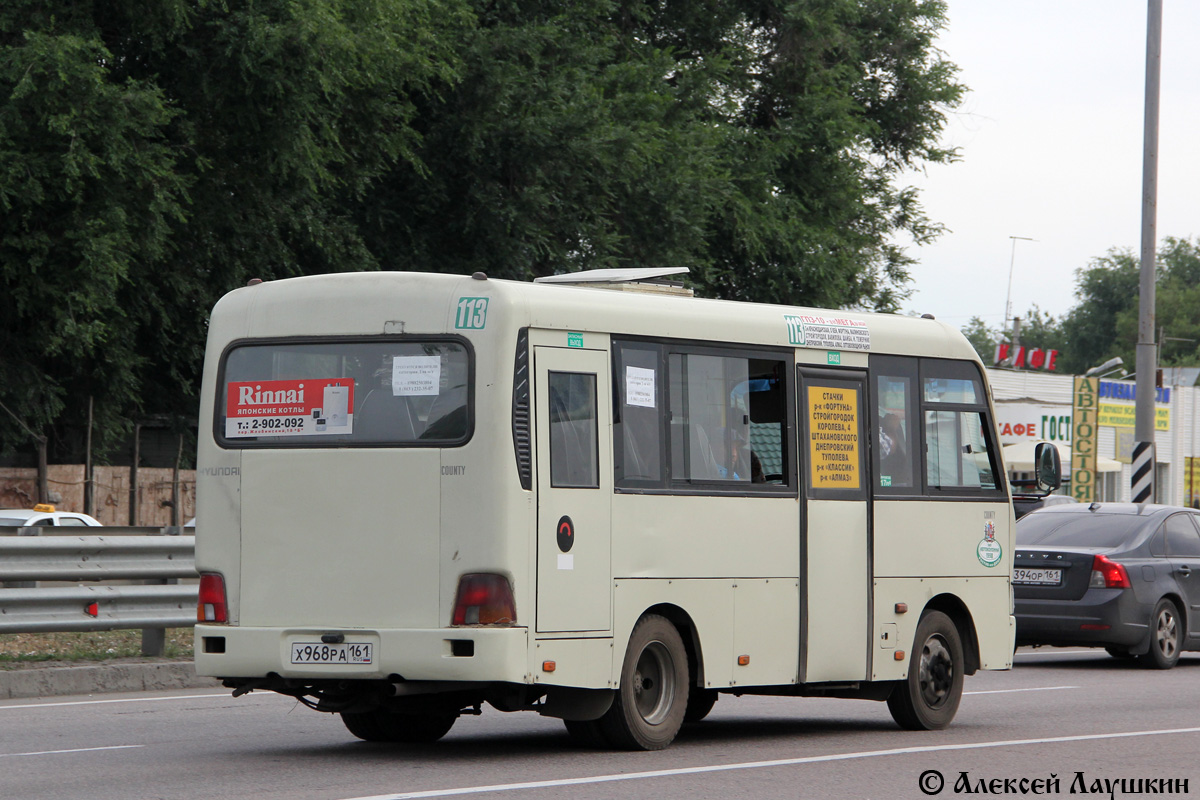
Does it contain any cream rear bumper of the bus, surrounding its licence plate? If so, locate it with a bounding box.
[196,625,529,684]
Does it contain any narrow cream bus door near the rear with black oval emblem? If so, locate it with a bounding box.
[534,347,613,632]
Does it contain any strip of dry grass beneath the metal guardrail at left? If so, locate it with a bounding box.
[0,627,192,668]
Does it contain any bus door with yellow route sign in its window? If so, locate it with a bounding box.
[797,367,871,682]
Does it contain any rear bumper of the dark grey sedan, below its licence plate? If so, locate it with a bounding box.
[1016,589,1153,648]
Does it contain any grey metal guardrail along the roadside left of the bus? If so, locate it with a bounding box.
[0,527,198,655]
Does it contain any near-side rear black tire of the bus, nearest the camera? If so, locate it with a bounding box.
[599,614,690,750]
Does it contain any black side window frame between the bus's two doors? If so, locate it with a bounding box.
[610,333,799,498]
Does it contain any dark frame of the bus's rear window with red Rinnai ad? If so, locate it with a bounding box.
[212,333,475,450]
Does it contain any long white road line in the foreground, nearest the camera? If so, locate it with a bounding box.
[346,728,1200,800]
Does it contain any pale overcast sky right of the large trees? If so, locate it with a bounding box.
[902,0,1200,329]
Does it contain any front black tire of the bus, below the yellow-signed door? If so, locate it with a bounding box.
[888,612,965,730]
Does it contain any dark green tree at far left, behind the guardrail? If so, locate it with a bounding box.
[0,0,470,459]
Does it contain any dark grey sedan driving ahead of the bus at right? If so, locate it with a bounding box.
[1013,503,1200,669]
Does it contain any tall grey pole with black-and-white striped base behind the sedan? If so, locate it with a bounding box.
[1130,0,1163,503]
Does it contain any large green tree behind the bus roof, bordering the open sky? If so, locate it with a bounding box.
[359,0,962,309]
